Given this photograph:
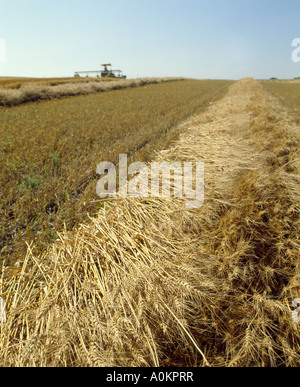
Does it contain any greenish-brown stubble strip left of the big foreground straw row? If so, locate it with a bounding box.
[0,80,231,262]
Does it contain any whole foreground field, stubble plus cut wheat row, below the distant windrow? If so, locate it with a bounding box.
[0,78,300,367]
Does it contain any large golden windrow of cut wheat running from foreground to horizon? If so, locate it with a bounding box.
[0,79,300,367]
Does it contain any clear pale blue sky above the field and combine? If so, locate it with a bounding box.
[0,0,300,79]
